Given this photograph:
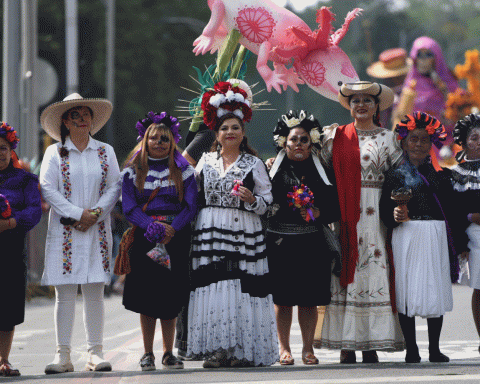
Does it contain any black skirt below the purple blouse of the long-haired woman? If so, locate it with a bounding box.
[123,225,191,320]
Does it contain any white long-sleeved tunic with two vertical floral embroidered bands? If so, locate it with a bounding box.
[40,137,121,285]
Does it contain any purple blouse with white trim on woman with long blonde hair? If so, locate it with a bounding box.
[122,154,198,231]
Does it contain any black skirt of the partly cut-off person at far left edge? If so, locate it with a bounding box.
[0,231,27,331]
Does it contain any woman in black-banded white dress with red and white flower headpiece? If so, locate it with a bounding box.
[187,81,279,368]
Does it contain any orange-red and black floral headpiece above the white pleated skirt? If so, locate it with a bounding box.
[395,112,447,148]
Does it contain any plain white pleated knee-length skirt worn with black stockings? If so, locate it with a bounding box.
[392,220,453,318]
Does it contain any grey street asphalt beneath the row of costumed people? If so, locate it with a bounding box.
[0,285,480,384]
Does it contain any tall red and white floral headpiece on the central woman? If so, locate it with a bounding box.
[202,81,252,129]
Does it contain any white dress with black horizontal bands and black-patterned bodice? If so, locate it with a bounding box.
[187,153,279,366]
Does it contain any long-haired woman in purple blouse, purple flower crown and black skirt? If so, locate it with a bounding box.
[122,112,197,371]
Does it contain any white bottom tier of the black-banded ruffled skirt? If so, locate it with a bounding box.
[187,280,279,366]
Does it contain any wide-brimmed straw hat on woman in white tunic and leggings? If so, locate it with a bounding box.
[40,93,113,141]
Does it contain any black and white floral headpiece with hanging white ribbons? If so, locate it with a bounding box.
[273,109,323,151]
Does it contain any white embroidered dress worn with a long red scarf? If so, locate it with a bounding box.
[320,124,403,351]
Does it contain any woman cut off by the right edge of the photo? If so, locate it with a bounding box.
[451,113,480,352]
